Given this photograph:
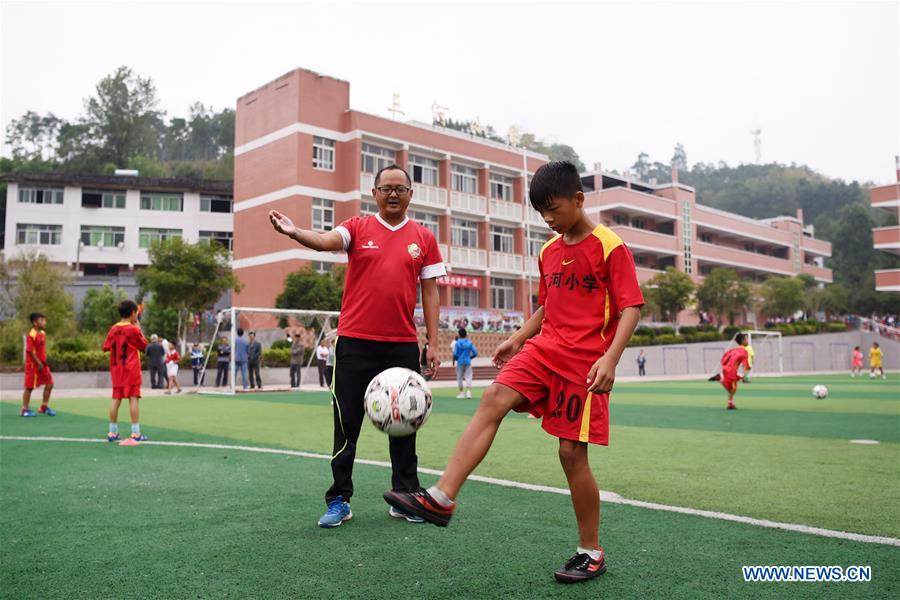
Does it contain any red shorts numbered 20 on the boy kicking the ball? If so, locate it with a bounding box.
[494,346,609,446]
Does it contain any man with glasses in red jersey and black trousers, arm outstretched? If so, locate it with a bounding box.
[269,165,447,527]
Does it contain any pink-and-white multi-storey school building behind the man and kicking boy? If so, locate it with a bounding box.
[234,69,831,318]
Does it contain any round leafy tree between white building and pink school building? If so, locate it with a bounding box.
[137,238,241,351]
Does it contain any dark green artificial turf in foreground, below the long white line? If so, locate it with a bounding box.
[0,436,900,599]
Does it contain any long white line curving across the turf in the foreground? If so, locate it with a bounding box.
[0,435,900,546]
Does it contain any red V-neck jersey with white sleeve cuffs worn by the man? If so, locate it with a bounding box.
[335,215,447,342]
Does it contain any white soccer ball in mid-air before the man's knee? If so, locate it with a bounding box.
[366,367,431,437]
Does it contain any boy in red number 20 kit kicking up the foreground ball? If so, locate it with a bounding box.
[384,161,644,583]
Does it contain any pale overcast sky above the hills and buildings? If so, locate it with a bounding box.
[0,1,900,183]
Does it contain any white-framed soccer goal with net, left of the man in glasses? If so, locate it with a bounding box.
[197,306,340,395]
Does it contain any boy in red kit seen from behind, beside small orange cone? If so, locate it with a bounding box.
[103,300,147,442]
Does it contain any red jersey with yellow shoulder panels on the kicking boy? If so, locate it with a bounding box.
[527,225,644,385]
